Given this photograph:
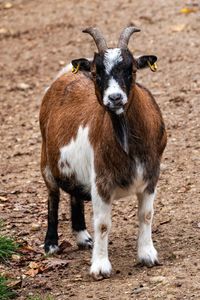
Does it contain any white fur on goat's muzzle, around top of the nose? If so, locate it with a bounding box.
[103,77,128,105]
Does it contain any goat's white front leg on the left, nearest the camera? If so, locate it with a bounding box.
[90,184,112,280]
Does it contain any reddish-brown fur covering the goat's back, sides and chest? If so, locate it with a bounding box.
[40,72,166,200]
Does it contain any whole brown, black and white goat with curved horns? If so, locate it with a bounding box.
[40,27,166,279]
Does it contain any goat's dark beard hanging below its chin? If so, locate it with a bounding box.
[110,112,129,154]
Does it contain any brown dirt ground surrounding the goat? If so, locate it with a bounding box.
[0,0,200,300]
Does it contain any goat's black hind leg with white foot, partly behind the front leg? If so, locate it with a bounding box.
[71,196,93,249]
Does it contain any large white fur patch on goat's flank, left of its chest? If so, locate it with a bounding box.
[58,126,93,188]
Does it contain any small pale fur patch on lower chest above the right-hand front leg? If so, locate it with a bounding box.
[113,159,148,199]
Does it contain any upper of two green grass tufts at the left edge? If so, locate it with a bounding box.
[0,235,18,261]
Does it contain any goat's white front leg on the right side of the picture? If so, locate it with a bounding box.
[137,191,158,267]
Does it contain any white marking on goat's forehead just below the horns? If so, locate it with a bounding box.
[103,48,123,75]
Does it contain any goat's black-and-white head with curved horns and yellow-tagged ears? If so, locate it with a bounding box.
[72,26,157,115]
